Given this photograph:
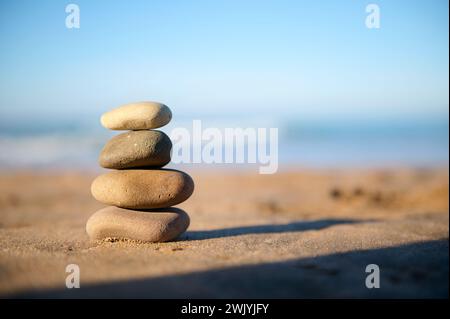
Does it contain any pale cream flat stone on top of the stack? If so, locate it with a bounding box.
[100,102,172,130]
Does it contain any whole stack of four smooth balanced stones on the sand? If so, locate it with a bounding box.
[86,102,194,242]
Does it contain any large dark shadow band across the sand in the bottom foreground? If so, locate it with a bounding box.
[9,240,449,298]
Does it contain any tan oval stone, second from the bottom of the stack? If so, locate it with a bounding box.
[91,169,194,209]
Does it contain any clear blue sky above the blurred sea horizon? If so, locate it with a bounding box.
[0,0,449,119]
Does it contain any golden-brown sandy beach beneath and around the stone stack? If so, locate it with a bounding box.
[0,169,449,298]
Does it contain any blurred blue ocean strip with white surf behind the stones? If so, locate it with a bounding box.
[0,116,449,170]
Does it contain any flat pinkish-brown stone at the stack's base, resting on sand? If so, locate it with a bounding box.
[86,206,189,242]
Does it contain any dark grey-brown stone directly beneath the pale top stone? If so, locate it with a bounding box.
[98,130,172,169]
